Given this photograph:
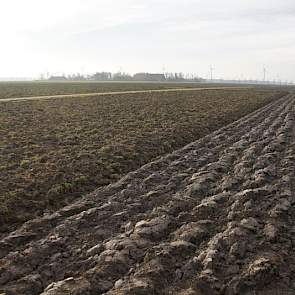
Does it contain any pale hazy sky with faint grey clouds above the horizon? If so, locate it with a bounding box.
[0,0,295,80]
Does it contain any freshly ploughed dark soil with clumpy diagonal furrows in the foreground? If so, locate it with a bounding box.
[0,95,295,295]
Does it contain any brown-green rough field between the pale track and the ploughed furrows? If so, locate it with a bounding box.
[0,89,285,231]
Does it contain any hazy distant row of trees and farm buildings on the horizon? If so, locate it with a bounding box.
[48,72,204,82]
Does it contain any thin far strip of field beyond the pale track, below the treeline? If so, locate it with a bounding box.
[0,82,224,99]
